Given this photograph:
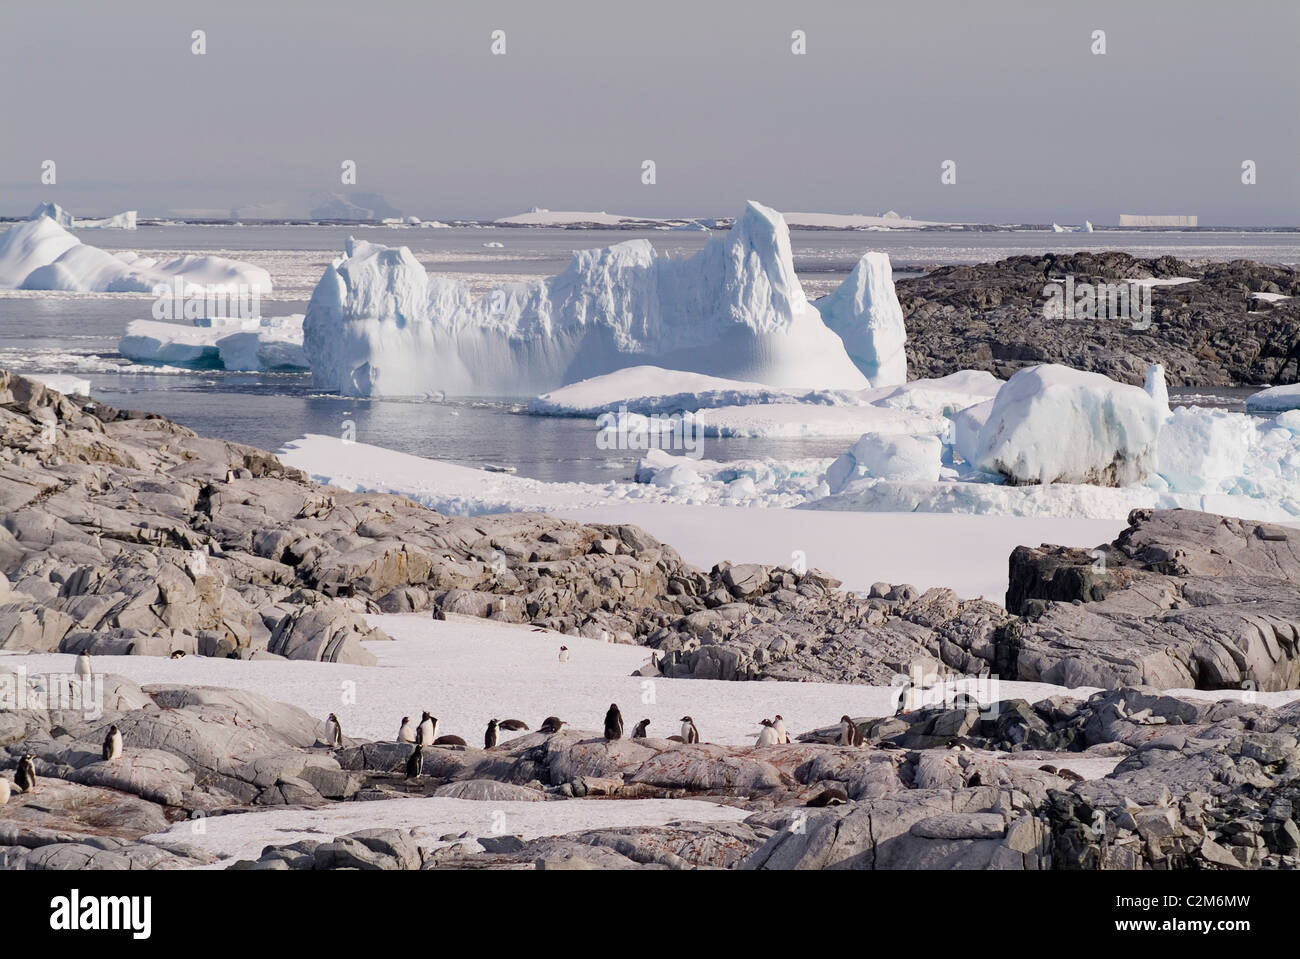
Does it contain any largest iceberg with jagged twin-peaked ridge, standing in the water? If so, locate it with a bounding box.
[304,203,868,396]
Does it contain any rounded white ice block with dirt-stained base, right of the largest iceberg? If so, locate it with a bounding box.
[975,364,1165,486]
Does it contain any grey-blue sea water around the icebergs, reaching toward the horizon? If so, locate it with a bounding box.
[0,225,1300,482]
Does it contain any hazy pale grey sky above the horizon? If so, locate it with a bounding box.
[0,0,1300,226]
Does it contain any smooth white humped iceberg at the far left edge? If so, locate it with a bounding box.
[0,216,272,294]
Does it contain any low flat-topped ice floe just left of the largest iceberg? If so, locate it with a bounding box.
[117,313,307,372]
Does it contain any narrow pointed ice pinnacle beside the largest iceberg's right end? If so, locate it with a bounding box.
[815,251,907,386]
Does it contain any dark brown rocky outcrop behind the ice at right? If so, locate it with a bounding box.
[896,252,1300,387]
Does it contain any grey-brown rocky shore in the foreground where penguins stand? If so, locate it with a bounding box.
[0,373,1300,869]
